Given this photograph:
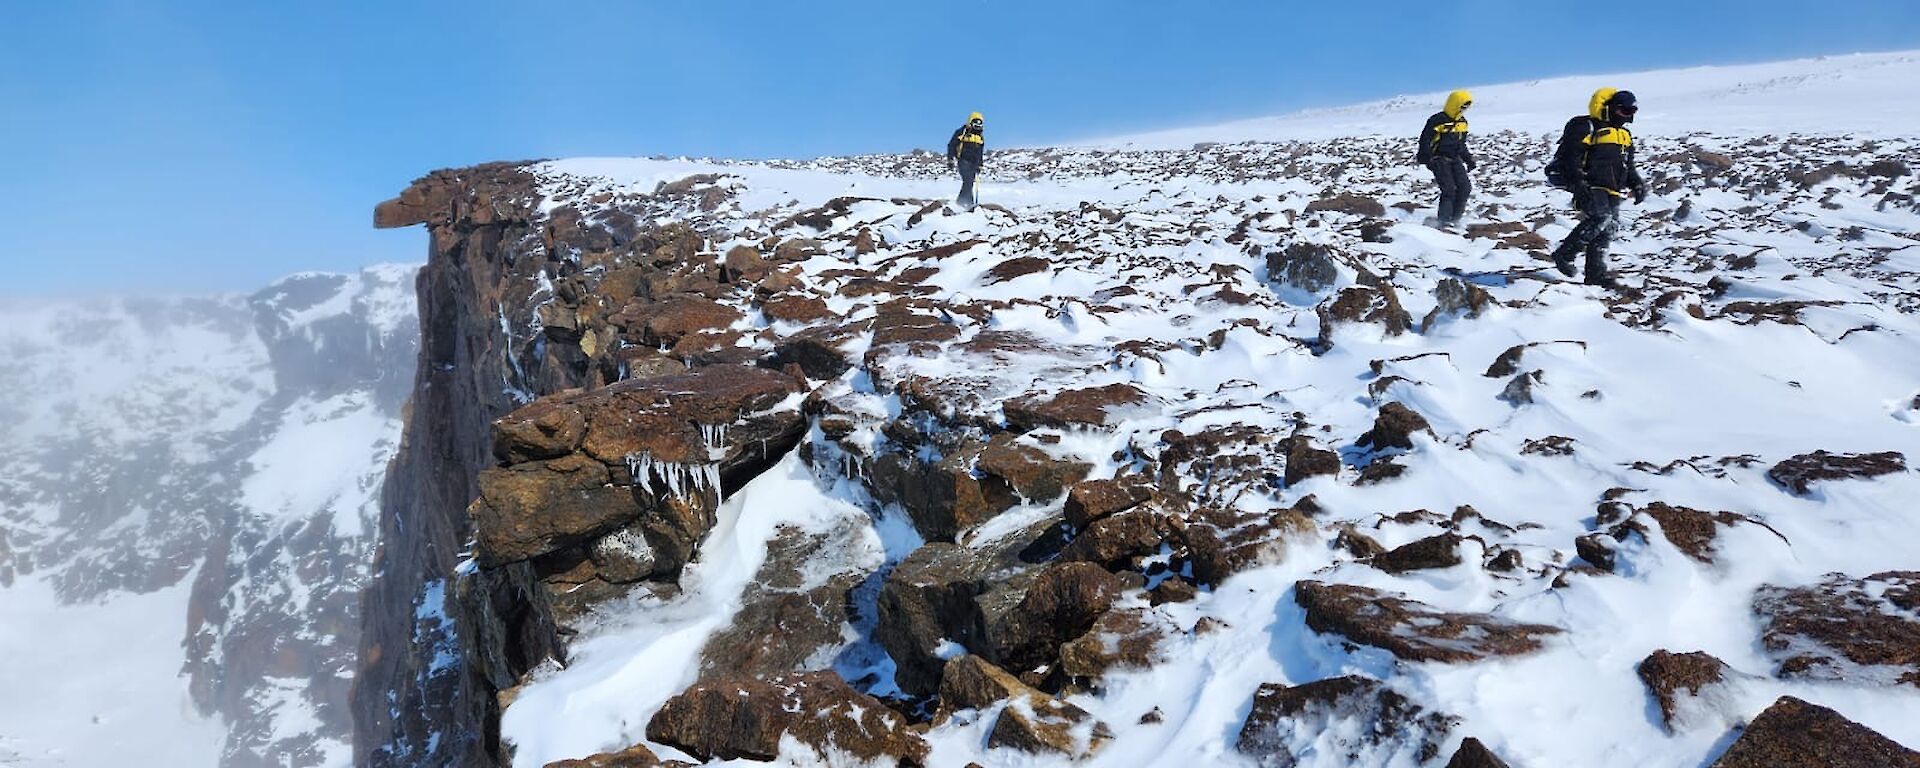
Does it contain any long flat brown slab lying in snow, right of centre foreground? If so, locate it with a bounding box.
[1294,582,1561,662]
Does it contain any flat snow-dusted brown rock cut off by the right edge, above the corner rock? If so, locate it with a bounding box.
[1753,570,1920,687]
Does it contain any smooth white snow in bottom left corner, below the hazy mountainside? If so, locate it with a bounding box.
[0,576,227,768]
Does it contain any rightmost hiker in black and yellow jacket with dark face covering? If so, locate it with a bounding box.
[1548,88,1647,288]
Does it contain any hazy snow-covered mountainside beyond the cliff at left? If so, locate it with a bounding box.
[0,265,419,766]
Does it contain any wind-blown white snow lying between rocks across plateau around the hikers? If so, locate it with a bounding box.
[501,54,1920,768]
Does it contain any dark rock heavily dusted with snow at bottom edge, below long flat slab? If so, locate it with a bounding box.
[1235,676,1457,768]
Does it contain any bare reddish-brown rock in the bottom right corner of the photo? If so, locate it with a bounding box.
[1711,697,1920,768]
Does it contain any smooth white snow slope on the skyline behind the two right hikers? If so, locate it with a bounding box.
[1068,50,1920,150]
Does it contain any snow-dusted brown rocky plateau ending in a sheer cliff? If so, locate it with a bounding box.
[355,125,1920,764]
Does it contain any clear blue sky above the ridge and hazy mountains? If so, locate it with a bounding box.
[11,0,1920,296]
